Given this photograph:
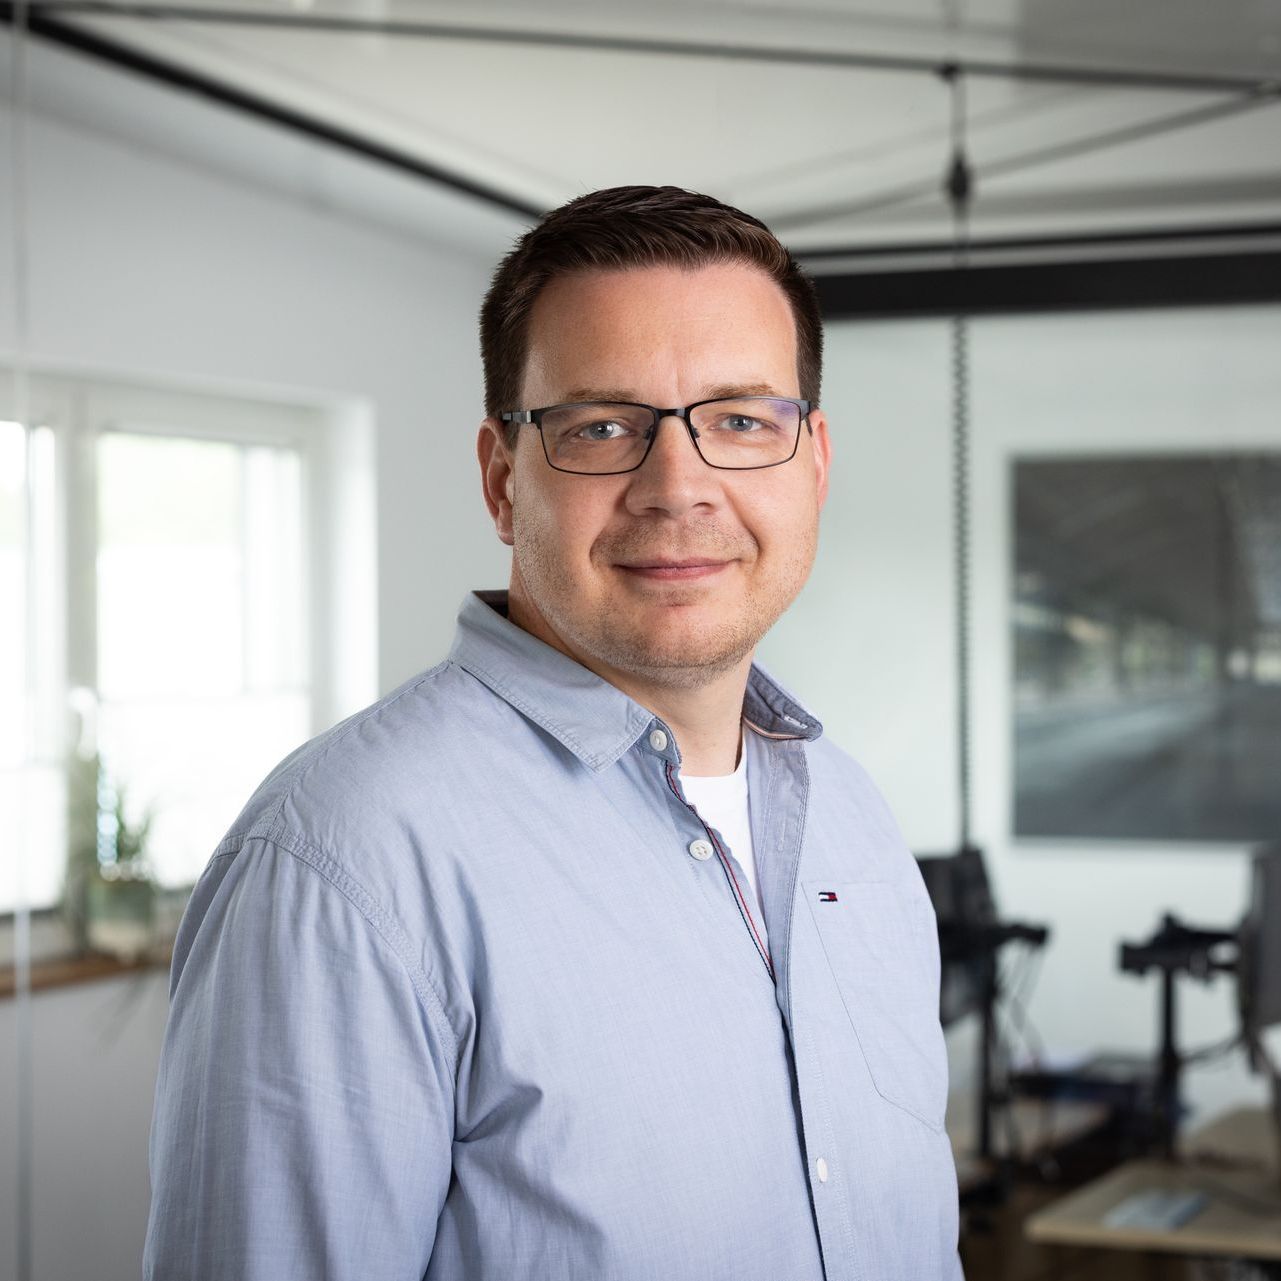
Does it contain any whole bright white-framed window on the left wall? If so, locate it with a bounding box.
[0,378,374,911]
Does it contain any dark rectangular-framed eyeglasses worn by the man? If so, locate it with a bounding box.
[498,396,813,475]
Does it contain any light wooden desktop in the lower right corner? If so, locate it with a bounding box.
[1024,1108,1281,1261]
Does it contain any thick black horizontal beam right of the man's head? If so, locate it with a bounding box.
[815,251,1281,320]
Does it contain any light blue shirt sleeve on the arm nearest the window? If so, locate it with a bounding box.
[143,839,455,1281]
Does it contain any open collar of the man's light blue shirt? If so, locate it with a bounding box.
[450,592,822,771]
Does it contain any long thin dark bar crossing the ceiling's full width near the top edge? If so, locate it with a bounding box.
[17,0,1277,92]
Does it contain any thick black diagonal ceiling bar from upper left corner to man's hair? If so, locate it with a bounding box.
[0,0,546,222]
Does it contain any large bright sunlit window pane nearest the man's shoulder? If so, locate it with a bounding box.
[97,432,310,885]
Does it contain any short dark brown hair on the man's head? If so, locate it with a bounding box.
[480,178,822,445]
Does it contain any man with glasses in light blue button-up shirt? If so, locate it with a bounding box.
[146,187,959,1281]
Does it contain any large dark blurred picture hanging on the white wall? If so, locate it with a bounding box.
[1011,452,1281,842]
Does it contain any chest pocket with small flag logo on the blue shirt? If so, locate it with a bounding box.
[803,881,948,1131]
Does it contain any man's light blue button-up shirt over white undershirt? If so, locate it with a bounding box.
[145,593,961,1281]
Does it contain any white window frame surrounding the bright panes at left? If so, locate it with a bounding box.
[0,371,377,927]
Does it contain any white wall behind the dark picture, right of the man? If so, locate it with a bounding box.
[762,307,1281,1132]
